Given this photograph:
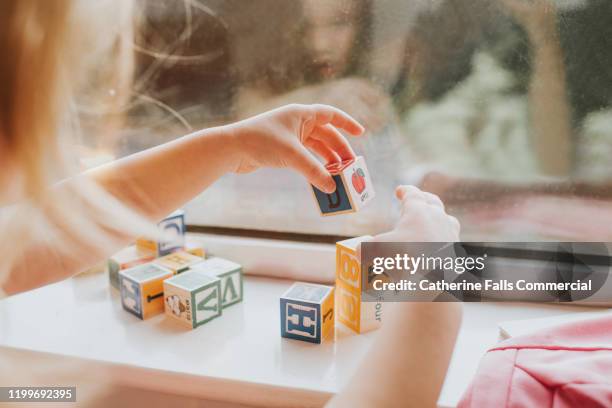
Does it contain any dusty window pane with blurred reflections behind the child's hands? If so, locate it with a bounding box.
[107,0,612,240]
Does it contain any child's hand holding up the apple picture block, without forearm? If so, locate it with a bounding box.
[229,104,364,193]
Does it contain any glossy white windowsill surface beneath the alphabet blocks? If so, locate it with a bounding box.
[0,274,604,407]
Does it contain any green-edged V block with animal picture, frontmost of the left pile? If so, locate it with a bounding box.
[164,271,223,328]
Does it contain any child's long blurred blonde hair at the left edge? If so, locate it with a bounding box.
[0,0,160,287]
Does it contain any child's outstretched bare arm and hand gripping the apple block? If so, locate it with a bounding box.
[89,105,363,220]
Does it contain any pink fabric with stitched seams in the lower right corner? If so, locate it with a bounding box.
[458,315,612,408]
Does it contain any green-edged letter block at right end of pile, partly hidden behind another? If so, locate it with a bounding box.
[191,257,243,308]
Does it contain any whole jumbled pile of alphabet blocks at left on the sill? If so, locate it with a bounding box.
[113,211,243,328]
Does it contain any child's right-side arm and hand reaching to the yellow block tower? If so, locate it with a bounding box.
[329,186,461,408]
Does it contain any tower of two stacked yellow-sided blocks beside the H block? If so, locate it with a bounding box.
[336,236,383,333]
